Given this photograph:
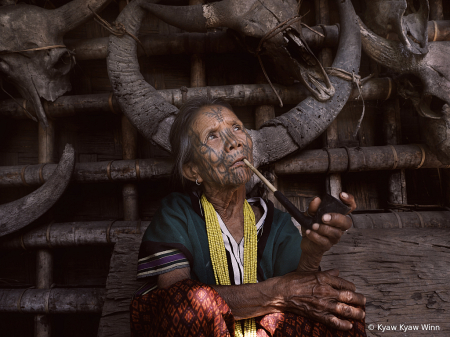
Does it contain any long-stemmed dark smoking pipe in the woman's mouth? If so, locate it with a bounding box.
[243,159,351,229]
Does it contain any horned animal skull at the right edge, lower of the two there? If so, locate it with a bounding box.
[359,13,450,164]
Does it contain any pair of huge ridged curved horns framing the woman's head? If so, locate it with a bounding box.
[107,0,361,163]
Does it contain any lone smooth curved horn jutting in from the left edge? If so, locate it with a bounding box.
[0,144,75,237]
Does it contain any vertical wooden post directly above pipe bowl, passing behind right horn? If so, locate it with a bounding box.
[314,0,342,198]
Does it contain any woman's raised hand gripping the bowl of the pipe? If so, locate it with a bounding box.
[297,192,356,271]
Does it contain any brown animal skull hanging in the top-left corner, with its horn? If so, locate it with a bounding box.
[0,0,109,126]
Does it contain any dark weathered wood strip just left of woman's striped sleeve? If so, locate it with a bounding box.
[97,234,143,337]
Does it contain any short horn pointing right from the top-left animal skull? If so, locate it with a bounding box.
[51,0,111,35]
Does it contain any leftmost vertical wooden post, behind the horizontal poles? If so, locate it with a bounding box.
[34,119,55,337]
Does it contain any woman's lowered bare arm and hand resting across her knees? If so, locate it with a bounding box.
[158,268,366,330]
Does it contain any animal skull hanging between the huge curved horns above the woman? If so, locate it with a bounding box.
[143,0,335,102]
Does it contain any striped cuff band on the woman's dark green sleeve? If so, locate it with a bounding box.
[137,249,189,278]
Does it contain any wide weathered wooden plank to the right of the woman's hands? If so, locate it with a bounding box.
[321,228,450,336]
